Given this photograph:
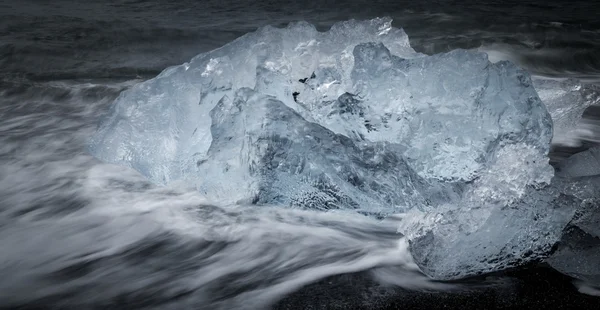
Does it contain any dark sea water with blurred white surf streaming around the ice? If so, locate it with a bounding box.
[0,0,600,309]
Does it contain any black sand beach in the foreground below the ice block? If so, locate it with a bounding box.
[273,264,600,310]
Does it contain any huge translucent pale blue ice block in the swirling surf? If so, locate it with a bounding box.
[90,18,579,279]
